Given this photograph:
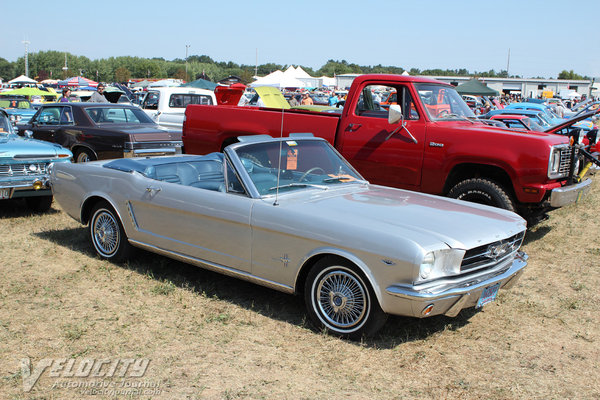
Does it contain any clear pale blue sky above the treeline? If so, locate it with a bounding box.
[0,0,600,78]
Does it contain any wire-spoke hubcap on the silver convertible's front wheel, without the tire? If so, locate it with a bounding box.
[315,270,368,329]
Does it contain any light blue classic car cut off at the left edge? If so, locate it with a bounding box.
[0,109,73,212]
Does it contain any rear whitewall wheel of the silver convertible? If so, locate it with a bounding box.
[89,201,131,262]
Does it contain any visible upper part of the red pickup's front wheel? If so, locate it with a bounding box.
[448,178,515,211]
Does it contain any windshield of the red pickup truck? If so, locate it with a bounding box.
[415,83,475,121]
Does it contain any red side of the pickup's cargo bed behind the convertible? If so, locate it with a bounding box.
[183,105,340,154]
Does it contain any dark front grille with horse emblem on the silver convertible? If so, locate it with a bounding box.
[460,231,525,273]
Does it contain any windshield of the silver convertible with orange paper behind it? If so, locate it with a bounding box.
[235,138,366,196]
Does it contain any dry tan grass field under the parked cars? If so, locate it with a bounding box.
[0,177,600,399]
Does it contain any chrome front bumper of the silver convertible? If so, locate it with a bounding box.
[385,251,529,318]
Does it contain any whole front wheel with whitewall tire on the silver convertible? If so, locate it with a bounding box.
[304,257,387,339]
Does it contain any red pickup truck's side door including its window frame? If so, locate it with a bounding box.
[338,84,426,189]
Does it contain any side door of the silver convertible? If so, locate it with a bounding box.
[128,159,253,272]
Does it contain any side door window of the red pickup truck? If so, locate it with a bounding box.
[356,85,419,120]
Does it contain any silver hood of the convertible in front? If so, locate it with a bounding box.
[280,185,526,249]
